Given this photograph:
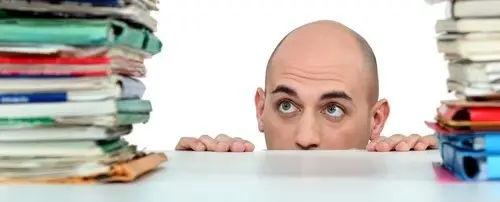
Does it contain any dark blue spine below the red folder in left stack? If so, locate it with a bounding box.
[0,92,68,104]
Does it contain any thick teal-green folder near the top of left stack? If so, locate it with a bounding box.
[0,18,162,55]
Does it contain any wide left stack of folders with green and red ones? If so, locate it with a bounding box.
[0,0,167,183]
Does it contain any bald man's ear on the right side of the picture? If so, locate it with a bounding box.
[370,99,391,140]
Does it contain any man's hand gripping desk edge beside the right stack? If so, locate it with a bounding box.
[366,134,438,152]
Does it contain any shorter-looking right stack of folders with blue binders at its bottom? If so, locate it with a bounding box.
[427,0,500,181]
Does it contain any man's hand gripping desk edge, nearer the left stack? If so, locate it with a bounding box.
[175,134,255,152]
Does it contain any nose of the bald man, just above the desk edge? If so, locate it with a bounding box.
[295,116,321,149]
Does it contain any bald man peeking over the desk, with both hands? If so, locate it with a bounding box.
[176,20,436,152]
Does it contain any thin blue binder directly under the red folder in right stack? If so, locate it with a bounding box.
[436,131,500,154]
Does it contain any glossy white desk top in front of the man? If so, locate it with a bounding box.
[0,151,500,202]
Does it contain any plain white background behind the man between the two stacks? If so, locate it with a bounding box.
[129,0,447,150]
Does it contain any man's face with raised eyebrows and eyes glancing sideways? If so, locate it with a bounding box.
[256,23,382,150]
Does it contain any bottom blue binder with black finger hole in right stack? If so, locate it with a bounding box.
[440,141,500,181]
